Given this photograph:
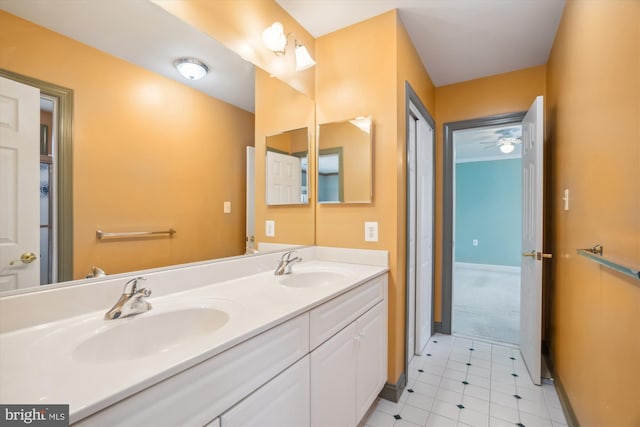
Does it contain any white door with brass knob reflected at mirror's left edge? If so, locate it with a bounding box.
[0,77,40,291]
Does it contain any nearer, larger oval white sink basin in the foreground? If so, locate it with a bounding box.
[72,307,229,363]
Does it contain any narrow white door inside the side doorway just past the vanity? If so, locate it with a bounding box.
[416,108,433,354]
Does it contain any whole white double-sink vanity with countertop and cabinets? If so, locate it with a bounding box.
[0,247,388,427]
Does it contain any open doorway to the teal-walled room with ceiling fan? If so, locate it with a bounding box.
[441,113,524,345]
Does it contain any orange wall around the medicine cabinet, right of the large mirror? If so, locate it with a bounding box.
[316,11,433,384]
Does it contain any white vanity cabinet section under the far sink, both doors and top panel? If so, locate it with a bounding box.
[308,276,387,427]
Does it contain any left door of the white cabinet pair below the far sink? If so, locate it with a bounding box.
[311,323,356,427]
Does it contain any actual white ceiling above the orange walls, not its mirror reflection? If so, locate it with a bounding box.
[276,0,565,86]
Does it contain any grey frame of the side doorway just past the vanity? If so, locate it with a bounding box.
[404,81,436,373]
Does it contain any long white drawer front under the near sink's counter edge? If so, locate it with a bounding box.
[77,314,309,427]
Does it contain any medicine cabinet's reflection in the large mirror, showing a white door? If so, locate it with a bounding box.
[265,127,309,205]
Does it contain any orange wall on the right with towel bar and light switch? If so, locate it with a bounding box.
[547,0,640,427]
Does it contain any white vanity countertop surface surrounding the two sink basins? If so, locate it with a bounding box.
[0,260,388,422]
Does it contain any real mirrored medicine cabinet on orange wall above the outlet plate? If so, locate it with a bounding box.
[317,116,373,204]
